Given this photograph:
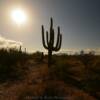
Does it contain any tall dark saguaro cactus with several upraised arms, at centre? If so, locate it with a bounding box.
[42,18,62,67]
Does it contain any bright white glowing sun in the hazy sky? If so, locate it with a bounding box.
[11,9,27,25]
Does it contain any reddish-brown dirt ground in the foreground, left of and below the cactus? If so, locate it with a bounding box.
[0,60,96,100]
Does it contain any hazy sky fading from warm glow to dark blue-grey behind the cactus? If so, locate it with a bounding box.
[0,0,100,51]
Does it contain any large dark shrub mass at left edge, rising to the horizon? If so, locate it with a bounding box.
[0,49,28,82]
